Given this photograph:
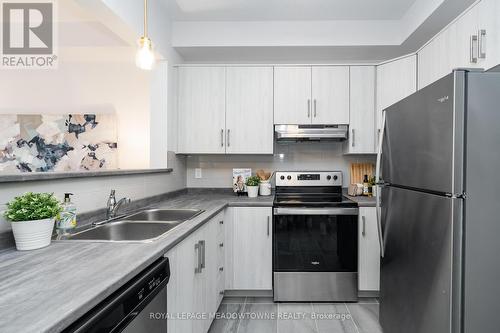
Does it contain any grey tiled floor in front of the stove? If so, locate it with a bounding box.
[209,297,382,333]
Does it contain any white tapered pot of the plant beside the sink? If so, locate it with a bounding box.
[11,218,54,251]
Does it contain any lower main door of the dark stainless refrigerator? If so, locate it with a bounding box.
[380,187,461,333]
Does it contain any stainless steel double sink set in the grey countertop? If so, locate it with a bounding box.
[58,209,203,242]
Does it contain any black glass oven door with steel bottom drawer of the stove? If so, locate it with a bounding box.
[273,207,358,302]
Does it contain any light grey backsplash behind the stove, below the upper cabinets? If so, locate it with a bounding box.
[187,142,376,187]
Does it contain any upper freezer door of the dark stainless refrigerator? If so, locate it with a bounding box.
[382,71,465,193]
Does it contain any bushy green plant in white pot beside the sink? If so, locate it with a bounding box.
[4,192,61,251]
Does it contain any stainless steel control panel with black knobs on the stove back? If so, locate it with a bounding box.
[276,171,342,186]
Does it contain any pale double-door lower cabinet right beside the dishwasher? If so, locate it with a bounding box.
[167,213,224,333]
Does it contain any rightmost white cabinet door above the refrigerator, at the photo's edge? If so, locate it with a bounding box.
[477,0,500,70]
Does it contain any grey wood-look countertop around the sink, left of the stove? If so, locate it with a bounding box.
[0,192,274,333]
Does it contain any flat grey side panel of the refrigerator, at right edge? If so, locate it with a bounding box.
[463,73,500,333]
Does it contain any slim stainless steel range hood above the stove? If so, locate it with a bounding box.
[274,125,349,141]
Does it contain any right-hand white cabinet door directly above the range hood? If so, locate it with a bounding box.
[312,66,349,125]
